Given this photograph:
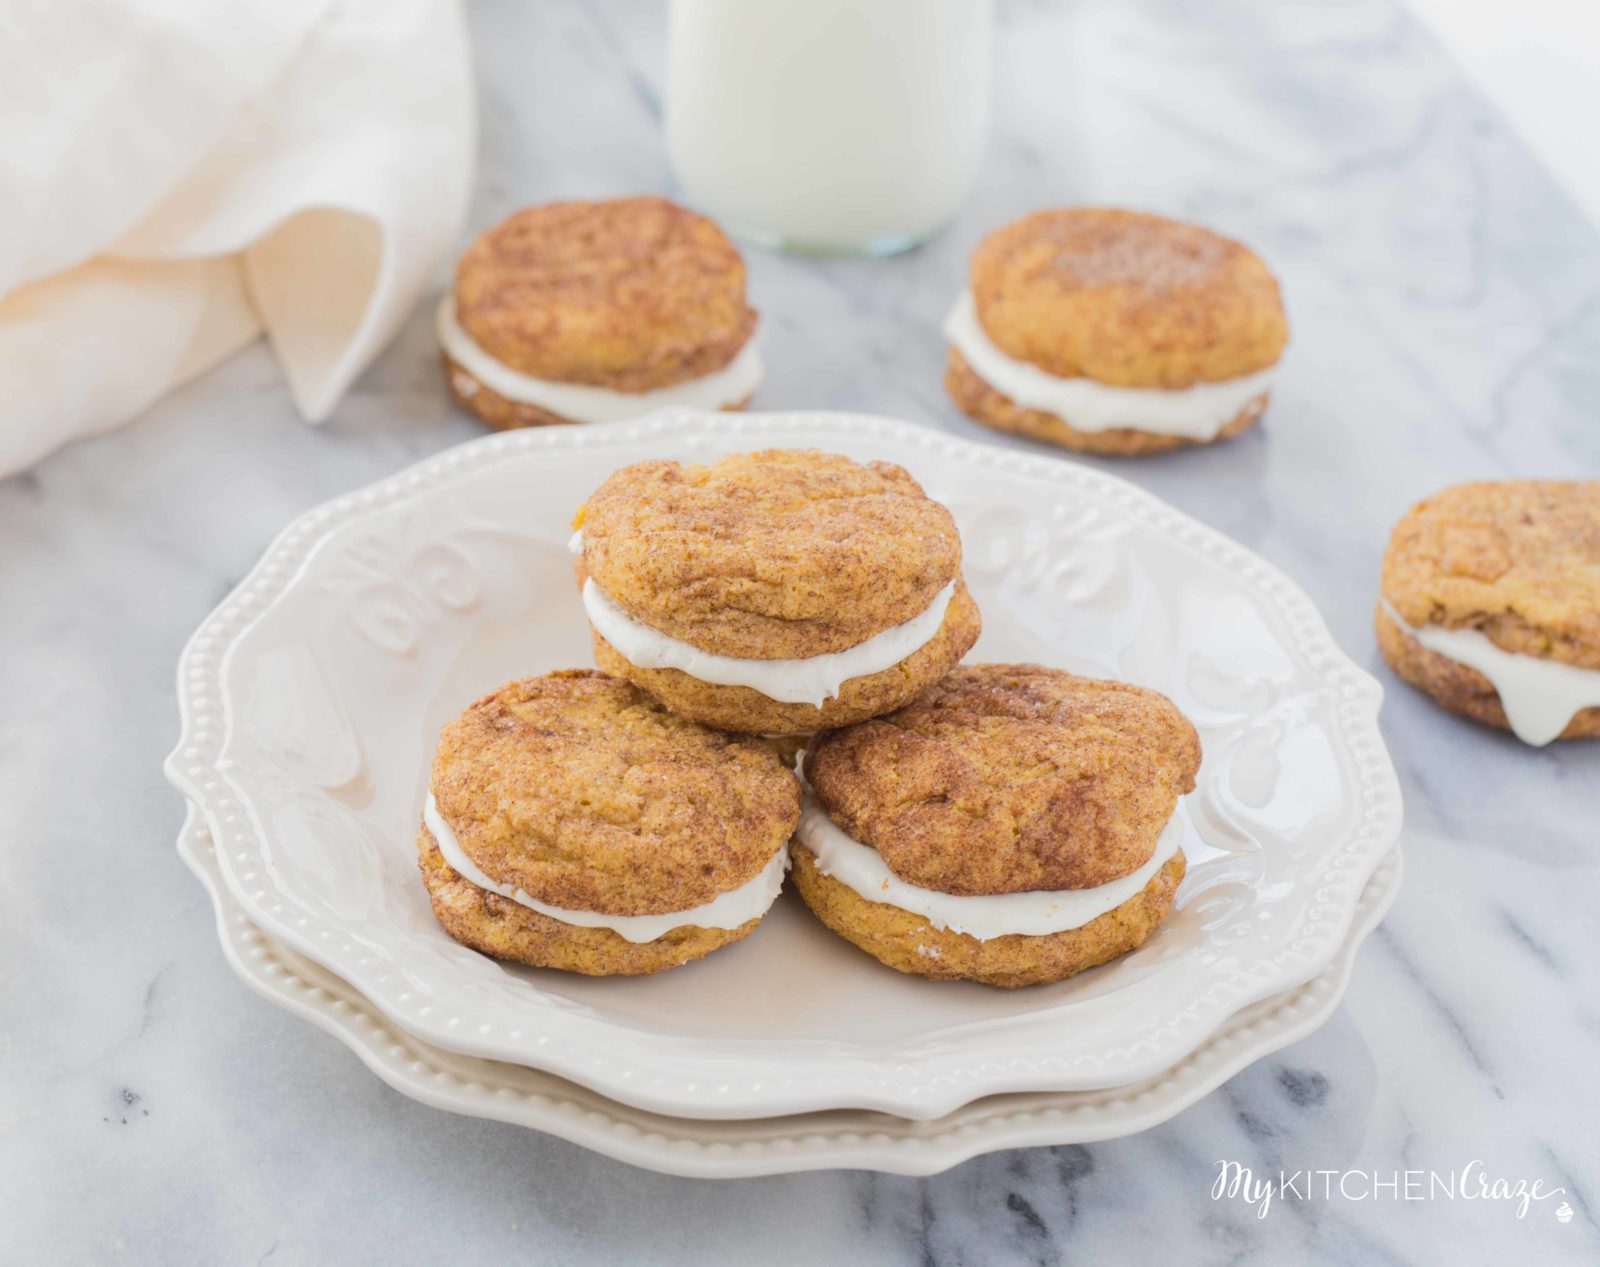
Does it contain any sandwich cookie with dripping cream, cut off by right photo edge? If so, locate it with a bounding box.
[1374,480,1600,745]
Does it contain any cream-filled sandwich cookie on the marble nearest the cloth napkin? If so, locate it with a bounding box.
[437,198,762,427]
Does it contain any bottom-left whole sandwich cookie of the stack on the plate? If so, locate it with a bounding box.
[418,669,800,976]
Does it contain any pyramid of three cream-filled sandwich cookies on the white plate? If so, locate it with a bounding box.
[419,450,1200,985]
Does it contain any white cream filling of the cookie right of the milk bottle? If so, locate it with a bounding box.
[944,291,1275,440]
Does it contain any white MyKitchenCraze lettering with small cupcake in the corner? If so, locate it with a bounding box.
[1211,1160,1573,1224]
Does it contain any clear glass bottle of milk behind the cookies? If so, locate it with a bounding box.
[667,0,994,254]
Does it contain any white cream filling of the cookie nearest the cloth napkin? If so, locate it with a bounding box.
[437,294,762,422]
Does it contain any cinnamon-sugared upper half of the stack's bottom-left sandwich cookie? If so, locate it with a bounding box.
[430,669,800,915]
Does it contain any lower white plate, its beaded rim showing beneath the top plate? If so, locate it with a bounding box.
[178,806,1400,1179]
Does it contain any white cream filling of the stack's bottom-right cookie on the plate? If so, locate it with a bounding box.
[795,795,1184,941]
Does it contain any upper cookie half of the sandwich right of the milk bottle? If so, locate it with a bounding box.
[971,206,1288,387]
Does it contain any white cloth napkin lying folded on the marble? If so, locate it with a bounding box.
[0,0,477,475]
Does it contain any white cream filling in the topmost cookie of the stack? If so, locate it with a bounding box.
[570,531,955,707]
